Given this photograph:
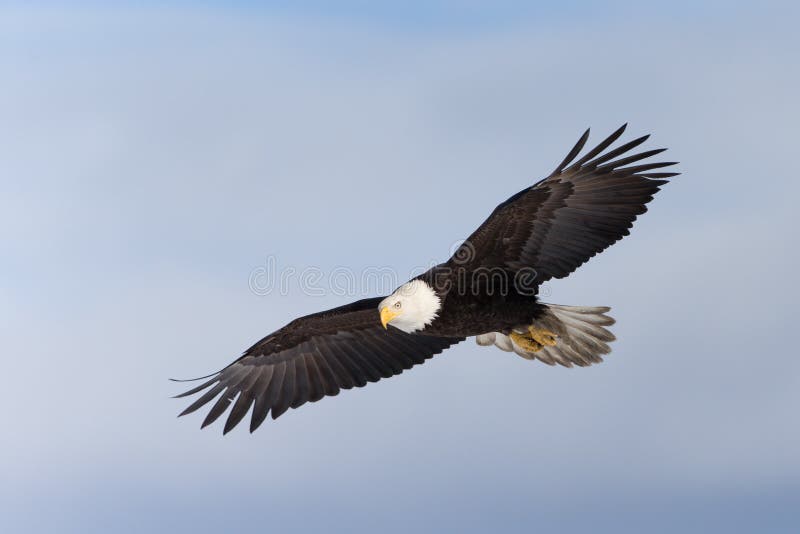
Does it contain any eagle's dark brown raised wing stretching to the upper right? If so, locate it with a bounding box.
[449,125,679,283]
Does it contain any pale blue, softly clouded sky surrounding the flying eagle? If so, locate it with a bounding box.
[0,2,800,532]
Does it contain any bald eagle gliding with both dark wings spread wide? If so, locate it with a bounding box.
[173,125,678,433]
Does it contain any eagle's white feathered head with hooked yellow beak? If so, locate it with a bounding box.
[378,280,442,334]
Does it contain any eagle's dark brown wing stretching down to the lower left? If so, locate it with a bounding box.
[178,298,464,433]
